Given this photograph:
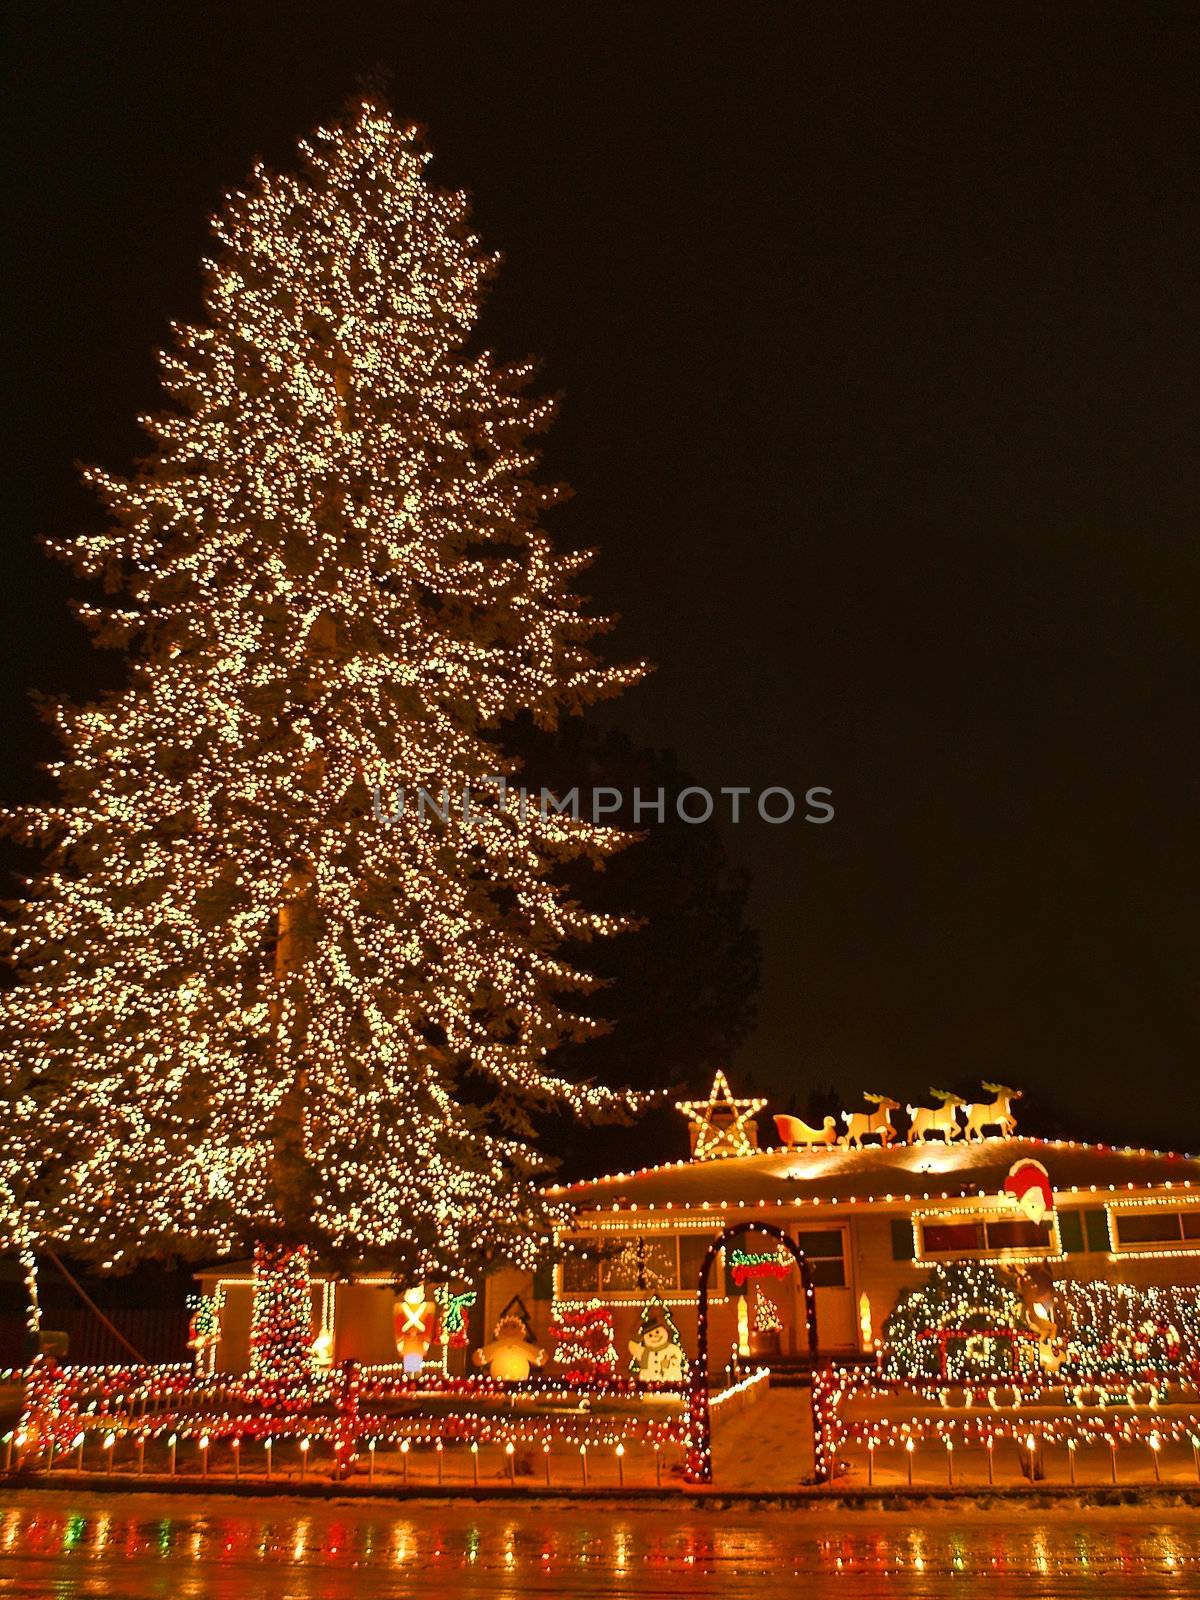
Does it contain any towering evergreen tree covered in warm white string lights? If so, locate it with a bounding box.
[0,104,649,1272]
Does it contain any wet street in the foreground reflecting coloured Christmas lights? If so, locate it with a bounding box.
[0,1491,1200,1600]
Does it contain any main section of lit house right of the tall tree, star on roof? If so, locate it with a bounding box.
[534,1078,1200,1365]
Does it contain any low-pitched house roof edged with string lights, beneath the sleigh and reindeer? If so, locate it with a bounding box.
[549,1138,1200,1211]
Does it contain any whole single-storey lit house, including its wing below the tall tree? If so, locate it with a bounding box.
[195,1075,1200,1371]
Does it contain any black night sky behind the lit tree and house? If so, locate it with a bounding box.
[0,0,1200,1154]
